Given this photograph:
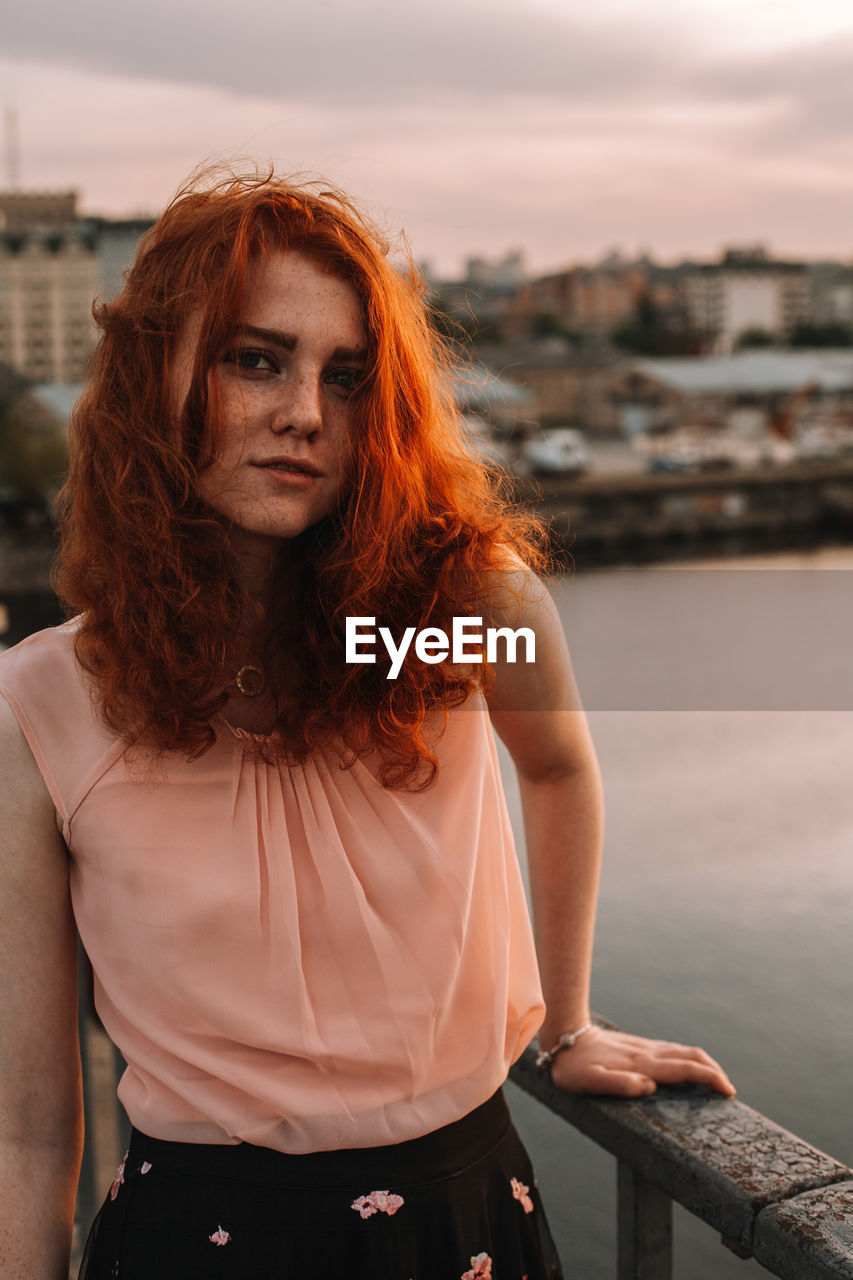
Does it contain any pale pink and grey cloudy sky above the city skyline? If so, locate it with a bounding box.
[0,0,853,275]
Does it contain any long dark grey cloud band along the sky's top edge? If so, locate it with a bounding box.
[4,0,696,104]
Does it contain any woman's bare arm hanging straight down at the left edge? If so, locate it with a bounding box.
[0,698,82,1280]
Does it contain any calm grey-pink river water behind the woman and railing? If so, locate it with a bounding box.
[505,552,853,1280]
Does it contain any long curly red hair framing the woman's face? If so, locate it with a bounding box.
[55,172,544,787]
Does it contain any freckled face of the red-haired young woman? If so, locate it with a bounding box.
[181,251,365,554]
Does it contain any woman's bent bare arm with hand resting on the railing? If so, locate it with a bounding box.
[489,570,734,1096]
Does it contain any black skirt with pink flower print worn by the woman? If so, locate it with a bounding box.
[79,1092,562,1280]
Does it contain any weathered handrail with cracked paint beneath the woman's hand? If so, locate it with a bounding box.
[510,1039,853,1280]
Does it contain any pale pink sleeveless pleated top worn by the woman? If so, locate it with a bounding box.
[0,623,544,1152]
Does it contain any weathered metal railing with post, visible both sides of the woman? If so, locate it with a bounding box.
[72,998,853,1280]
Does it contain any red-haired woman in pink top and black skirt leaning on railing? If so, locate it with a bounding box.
[0,175,731,1280]
